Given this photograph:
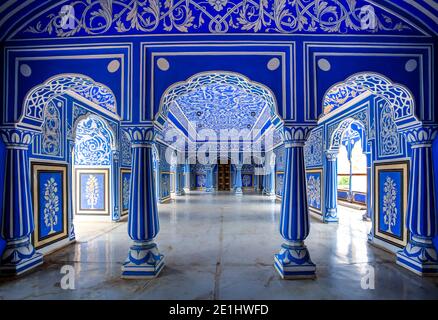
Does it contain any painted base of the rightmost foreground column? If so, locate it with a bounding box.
[397,236,438,277]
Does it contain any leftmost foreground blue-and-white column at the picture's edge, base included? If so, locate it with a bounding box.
[0,129,43,276]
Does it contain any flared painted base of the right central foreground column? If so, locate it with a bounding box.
[274,241,316,280]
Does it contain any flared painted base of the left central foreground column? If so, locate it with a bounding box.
[122,241,164,279]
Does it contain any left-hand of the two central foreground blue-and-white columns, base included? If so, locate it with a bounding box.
[122,127,164,279]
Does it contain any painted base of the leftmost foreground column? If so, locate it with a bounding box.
[0,237,43,276]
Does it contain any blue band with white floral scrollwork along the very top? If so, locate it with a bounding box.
[25,0,411,37]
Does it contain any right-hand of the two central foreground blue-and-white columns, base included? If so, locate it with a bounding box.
[274,126,316,279]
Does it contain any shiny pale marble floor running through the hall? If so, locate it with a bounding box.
[0,192,438,299]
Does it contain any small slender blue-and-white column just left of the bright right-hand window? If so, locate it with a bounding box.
[323,150,338,223]
